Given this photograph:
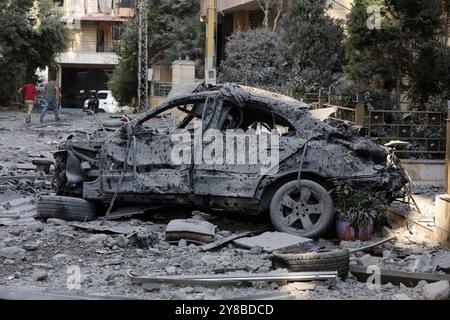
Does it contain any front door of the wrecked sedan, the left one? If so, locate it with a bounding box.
[103,96,207,195]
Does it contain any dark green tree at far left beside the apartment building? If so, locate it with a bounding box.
[0,0,69,105]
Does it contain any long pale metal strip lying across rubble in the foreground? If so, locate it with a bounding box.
[127,271,337,285]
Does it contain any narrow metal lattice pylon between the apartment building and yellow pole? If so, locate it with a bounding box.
[136,0,149,112]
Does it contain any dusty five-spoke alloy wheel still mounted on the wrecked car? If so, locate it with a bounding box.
[270,180,334,238]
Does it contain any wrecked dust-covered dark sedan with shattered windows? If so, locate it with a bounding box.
[45,84,406,238]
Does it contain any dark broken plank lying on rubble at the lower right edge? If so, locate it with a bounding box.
[350,266,450,288]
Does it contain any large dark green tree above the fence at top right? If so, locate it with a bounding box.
[346,0,450,106]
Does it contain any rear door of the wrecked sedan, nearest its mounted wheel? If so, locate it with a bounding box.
[194,104,305,198]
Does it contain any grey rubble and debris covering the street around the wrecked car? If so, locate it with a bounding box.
[0,110,449,300]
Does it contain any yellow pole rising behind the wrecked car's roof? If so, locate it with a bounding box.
[205,0,217,85]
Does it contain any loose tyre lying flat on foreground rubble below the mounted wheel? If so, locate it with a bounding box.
[272,249,350,279]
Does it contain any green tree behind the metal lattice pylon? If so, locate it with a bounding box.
[109,0,205,103]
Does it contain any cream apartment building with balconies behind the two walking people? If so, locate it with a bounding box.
[55,0,135,108]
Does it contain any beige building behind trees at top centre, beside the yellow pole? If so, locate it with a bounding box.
[200,0,353,66]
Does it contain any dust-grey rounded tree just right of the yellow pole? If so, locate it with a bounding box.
[220,28,283,91]
